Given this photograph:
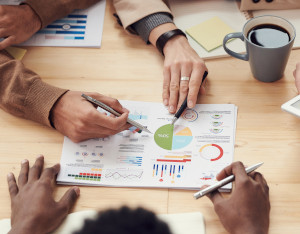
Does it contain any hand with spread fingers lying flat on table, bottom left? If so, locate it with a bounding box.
[7,156,80,234]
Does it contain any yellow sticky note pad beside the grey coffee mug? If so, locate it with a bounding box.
[186,16,234,51]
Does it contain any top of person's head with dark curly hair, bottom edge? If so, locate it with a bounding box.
[74,207,171,234]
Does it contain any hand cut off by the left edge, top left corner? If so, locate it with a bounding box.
[0,4,42,50]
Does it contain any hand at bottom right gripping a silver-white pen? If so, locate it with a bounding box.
[207,162,270,234]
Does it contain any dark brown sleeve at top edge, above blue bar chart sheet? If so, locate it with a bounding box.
[23,0,100,28]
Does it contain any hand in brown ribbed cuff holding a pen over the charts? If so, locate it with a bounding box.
[50,91,130,142]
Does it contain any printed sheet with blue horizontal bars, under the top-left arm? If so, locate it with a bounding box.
[20,0,106,47]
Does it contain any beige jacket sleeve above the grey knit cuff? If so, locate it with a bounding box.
[113,0,172,29]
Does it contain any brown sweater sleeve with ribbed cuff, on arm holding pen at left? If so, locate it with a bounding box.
[0,51,67,127]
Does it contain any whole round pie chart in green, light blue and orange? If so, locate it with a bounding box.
[154,124,193,150]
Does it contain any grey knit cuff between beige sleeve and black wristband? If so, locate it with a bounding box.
[131,12,173,44]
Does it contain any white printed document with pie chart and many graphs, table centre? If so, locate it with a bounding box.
[57,101,237,189]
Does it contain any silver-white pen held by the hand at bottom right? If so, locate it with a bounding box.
[194,162,264,199]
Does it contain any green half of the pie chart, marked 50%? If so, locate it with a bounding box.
[154,124,174,150]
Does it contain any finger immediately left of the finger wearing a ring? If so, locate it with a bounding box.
[169,64,180,114]
